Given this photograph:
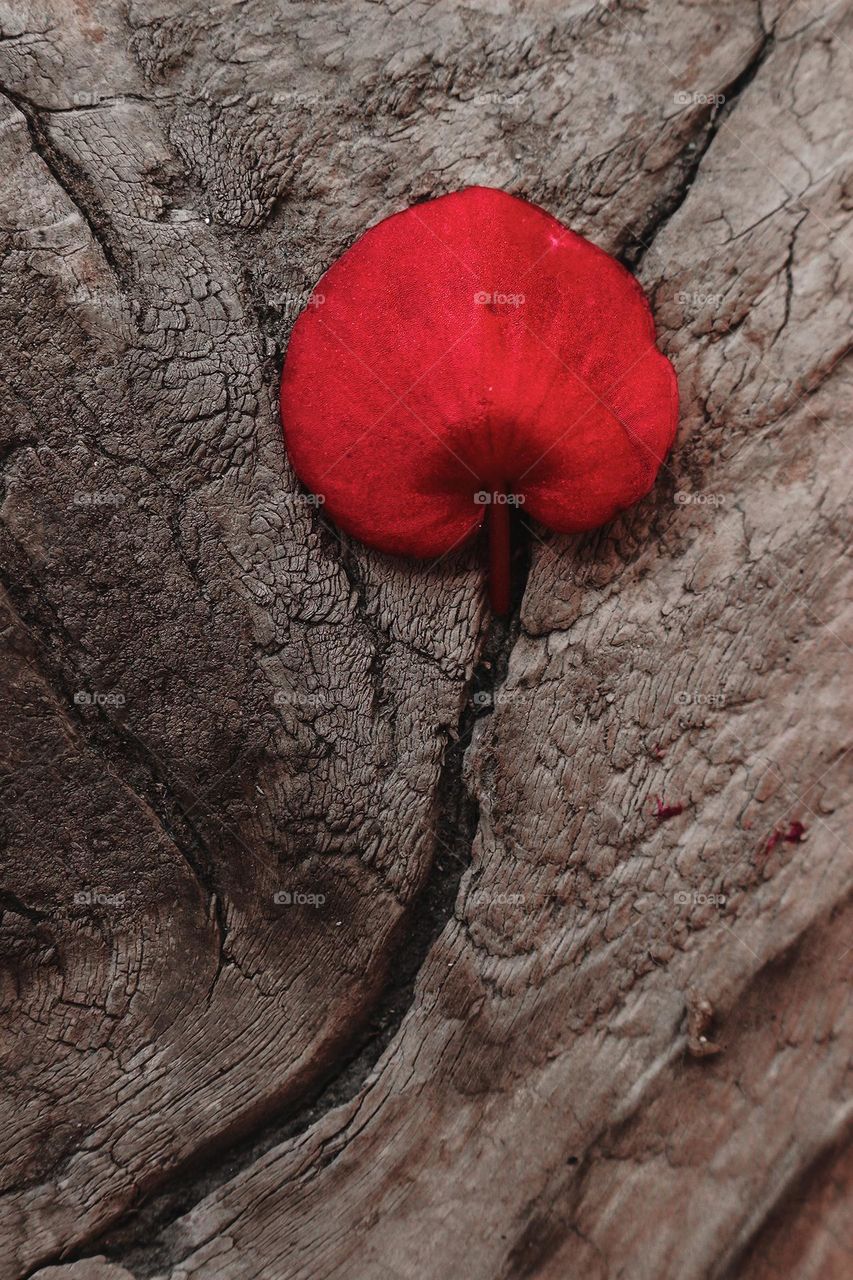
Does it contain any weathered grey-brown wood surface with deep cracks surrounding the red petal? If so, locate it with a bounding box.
[0,0,853,1280]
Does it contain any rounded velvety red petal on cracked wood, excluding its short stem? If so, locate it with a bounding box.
[282,187,678,558]
